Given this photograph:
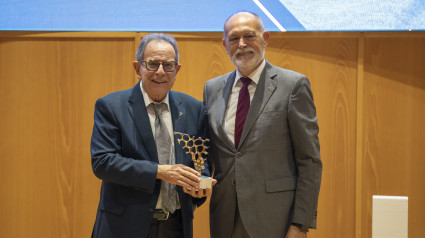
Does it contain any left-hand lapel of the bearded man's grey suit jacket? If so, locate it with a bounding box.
[216,71,236,150]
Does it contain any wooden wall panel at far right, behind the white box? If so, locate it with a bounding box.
[362,37,425,238]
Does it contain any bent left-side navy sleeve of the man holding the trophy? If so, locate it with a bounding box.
[90,99,158,193]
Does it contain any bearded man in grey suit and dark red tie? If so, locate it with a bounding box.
[204,12,322,238]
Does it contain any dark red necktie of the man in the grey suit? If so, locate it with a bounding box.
[235,77,251,149]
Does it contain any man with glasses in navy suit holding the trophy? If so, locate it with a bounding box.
[91,34,216,238]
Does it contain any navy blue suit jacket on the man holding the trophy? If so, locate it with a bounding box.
[91,83,209,238]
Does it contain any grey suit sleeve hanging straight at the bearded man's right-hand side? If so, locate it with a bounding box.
[288,77,322,228]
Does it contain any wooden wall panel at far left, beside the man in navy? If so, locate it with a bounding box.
[0,38,135,237]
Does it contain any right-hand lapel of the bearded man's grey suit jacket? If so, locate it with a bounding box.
[239,61,277,145]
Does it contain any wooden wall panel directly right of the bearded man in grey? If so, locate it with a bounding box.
[266,37,357,238]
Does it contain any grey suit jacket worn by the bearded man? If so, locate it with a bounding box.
[204,62,322,238]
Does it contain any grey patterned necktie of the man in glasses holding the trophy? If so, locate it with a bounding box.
[151,103,177,213]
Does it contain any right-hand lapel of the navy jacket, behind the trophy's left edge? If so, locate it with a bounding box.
[169,91,186,164]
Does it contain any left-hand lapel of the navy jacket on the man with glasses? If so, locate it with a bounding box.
[128,83,158,163]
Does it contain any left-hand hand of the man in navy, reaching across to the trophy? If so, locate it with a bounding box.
[156,164,201,189]
